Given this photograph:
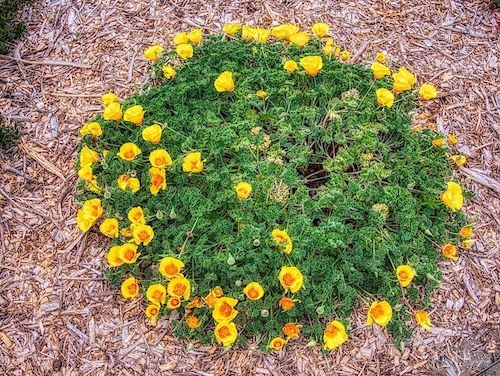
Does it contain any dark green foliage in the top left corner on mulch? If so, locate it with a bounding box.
[0,0,31,54]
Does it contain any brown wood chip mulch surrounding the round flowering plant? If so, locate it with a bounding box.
[0,0,500,375]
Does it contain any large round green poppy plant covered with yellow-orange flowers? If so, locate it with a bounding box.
[77,30,465,349]
